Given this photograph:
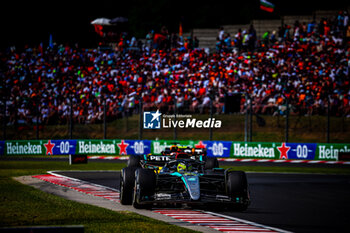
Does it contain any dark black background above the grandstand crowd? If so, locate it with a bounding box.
[0,0,347,48]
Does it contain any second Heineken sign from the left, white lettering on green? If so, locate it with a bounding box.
[78,141,116,154]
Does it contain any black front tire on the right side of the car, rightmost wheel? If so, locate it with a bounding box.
[226,171,250,211]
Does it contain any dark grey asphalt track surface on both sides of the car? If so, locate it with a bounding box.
[59,172,350,232]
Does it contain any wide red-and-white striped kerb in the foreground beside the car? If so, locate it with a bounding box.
[32,172,287,233]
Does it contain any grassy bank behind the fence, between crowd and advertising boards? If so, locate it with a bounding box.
[7,114,350,143]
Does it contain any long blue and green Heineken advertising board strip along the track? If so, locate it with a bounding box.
[0,139,350,161]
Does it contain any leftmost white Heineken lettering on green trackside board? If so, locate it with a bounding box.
[6,142,42,155]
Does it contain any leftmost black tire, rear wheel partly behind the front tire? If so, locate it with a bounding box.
[119,167,137,205]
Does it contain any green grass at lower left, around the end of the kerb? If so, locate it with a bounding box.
[0,161,193,232]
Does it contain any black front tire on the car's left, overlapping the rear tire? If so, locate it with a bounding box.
[132,168,156,209]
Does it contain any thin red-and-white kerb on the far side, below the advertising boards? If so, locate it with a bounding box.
[88,156,350,165]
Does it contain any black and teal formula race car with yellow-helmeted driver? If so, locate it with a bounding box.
[120,150,250,211]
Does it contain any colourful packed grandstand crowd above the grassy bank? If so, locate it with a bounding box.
[0,11,350,124]
